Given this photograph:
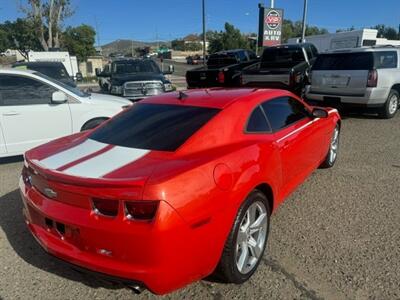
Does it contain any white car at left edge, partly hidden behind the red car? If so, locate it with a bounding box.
[0,69,132,157]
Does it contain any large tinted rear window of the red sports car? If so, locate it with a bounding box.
[90,103,220,151]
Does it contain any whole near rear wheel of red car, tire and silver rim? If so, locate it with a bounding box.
[216,190,270,283]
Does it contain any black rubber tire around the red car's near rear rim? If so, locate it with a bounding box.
[214,190,271,284]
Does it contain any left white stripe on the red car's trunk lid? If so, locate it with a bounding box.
[40,139,108,169]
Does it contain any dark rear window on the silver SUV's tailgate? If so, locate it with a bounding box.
[313,52,374,71]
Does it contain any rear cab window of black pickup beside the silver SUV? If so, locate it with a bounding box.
[261,47,305,68]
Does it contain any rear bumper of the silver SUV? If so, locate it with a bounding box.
[306,86,389,107]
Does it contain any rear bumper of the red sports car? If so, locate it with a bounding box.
[20,179,205,294]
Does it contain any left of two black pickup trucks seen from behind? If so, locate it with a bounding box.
[186,49,258,88]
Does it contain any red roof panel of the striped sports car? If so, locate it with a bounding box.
[140,88,290,109]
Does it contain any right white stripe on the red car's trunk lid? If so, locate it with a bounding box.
[64,146,150,178]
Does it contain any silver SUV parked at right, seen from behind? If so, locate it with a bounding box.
[306,46,400,119]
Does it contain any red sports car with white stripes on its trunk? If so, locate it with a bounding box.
[20,89,341,294]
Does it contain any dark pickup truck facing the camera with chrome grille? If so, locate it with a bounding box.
[96,59,174,101]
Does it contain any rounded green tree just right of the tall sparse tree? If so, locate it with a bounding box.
[62,24,96,61]
